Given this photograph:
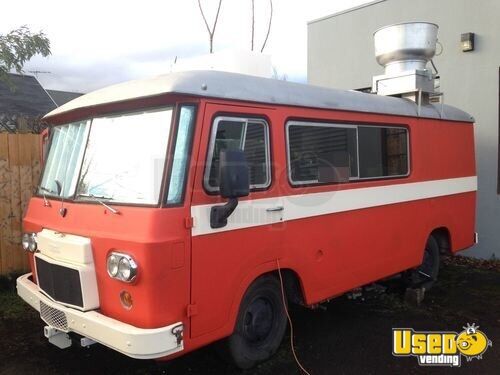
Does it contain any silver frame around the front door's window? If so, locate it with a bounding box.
[203,115,272,194]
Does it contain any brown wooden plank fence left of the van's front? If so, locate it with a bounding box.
[0,133,40,274]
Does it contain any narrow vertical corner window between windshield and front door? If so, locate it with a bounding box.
[167,105,195,204]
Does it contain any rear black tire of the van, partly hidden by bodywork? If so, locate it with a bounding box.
[404,236,440,290]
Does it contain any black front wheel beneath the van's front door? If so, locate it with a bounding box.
[226,275,287,369]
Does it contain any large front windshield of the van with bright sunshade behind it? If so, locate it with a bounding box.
[38,108,172,204]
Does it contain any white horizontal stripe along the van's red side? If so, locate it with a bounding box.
[191,176,477,236]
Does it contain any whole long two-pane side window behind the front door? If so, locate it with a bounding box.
[287,122,409,185]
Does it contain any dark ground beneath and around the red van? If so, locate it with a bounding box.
[0,257,500,375]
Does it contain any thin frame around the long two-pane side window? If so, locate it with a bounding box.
[285,120,411,188]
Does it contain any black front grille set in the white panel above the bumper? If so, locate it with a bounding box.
[35,257,83,307]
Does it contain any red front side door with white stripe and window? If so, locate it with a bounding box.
[191,103,283,337]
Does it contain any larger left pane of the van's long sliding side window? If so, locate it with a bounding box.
[288,123,358,185]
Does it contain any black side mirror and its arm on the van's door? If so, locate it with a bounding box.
[210,150,250,228]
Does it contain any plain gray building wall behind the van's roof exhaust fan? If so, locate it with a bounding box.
[307,0,500,258]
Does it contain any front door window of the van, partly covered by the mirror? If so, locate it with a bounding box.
[204,117,271,192]
